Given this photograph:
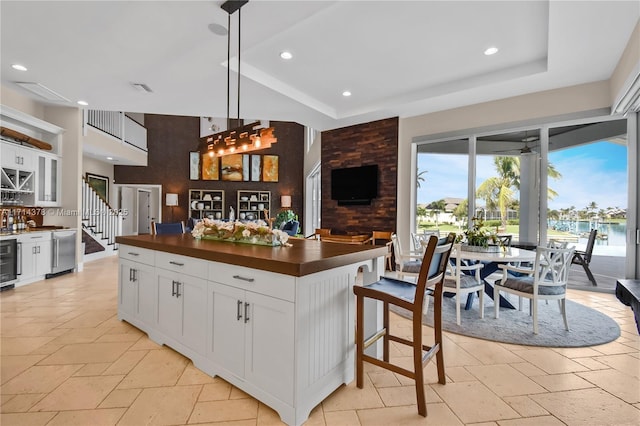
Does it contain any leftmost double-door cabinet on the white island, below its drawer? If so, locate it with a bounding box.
[118,259,156,325]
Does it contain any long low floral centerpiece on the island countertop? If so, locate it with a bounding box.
[191,219,291,246]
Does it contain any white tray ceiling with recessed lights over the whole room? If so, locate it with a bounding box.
[0,0,640,130]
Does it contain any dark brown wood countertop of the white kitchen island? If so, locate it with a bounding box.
[116,234,387,277]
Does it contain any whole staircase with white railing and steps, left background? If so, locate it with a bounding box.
[82,178,122,261]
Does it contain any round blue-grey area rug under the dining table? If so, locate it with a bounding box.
[392,297,620,348]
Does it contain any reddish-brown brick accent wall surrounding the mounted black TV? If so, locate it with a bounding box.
[321,117,399,234]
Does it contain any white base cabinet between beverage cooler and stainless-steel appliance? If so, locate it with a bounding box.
[18,232,52,284]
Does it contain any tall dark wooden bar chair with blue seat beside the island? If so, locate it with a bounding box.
[353,234,455,417]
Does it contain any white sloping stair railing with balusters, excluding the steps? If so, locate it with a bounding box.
[82,177,123,250]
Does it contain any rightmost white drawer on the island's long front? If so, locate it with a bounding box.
[209,262,296,302]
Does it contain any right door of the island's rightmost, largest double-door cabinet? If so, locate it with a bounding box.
[245,292,295,404]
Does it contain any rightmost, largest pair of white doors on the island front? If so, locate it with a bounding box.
[209,283,295,404]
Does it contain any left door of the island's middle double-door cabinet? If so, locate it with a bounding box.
[156,269,182,340]
